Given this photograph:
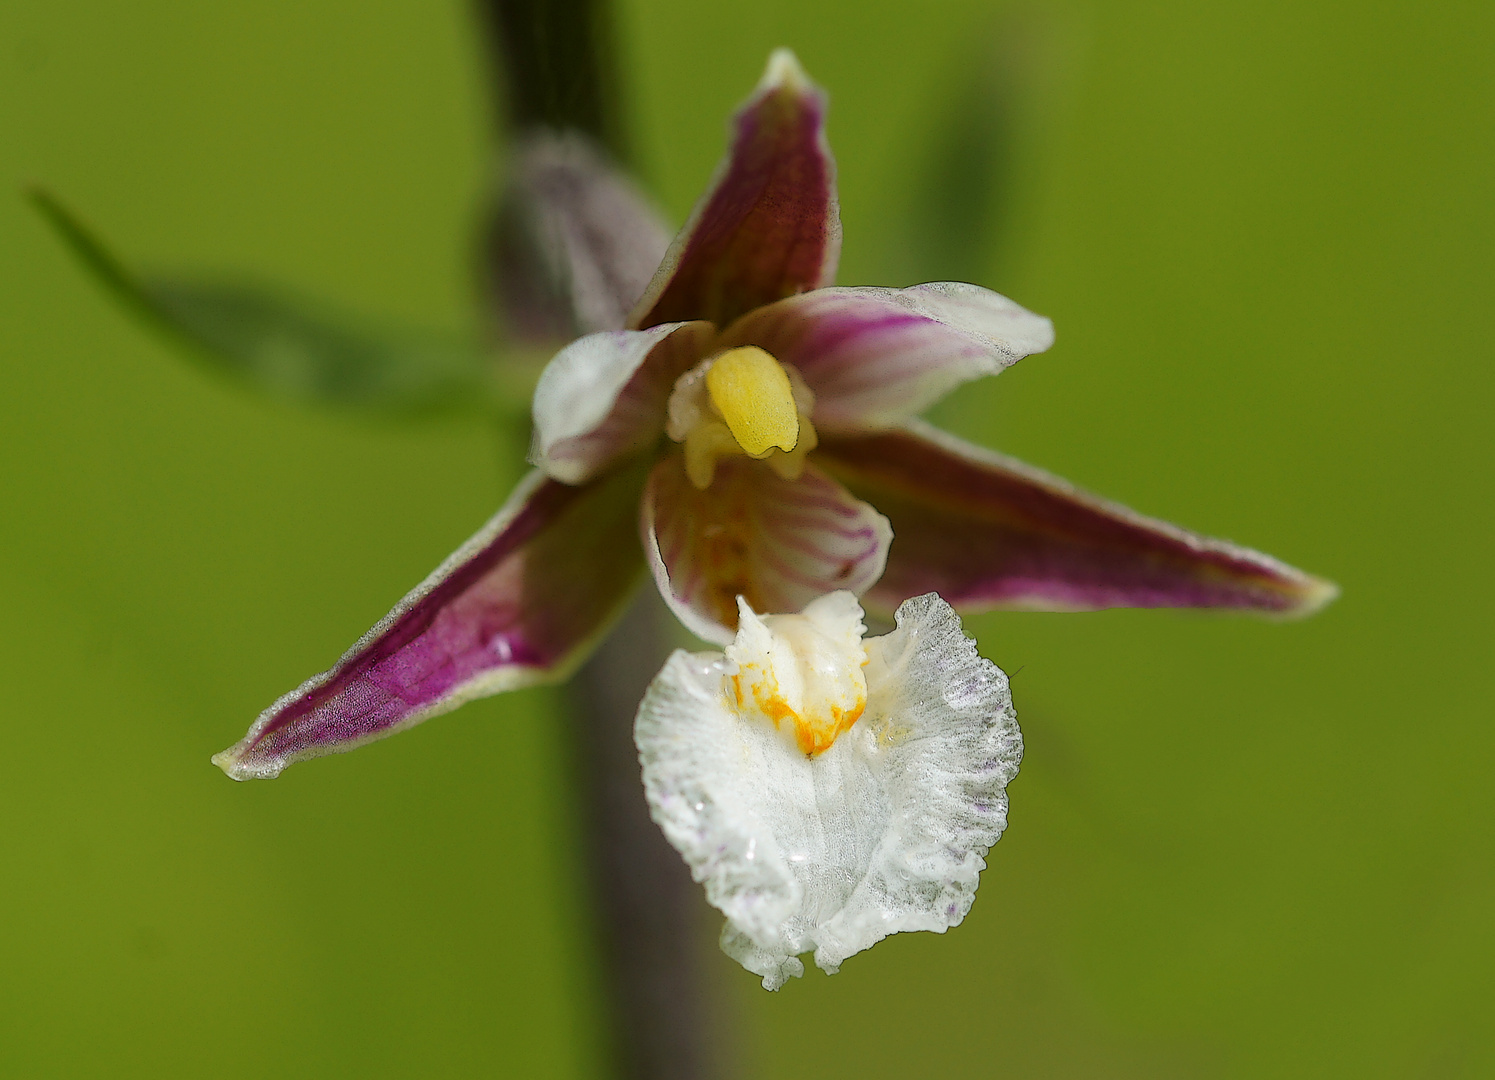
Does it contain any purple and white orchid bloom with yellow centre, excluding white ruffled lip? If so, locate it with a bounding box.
[214,51,1334,779]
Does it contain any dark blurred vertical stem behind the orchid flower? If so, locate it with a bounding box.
[478,0,725,1080]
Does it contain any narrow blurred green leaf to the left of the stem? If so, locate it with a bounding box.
[28,188,531,414]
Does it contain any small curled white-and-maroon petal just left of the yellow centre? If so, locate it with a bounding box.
[529,322,716,483]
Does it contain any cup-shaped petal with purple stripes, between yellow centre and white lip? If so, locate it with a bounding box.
[641,453,893,645]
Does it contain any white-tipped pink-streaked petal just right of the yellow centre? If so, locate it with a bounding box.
[722,281,1054,434]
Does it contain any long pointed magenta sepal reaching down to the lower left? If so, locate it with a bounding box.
[214,468,643,779]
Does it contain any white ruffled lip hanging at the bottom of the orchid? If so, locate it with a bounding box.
[634,592,1023,990]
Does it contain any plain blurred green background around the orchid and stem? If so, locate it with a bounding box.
[0,0,1495,1077]
